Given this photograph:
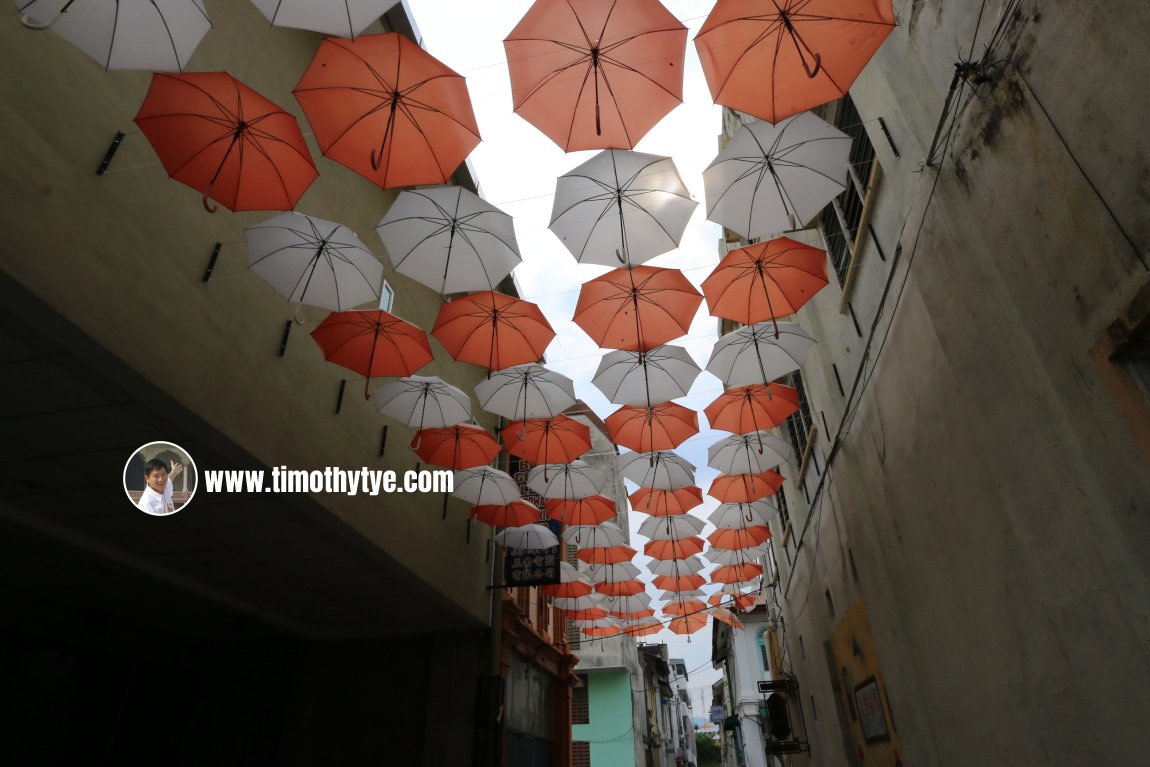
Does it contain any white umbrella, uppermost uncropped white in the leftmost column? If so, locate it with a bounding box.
[244,213,383,312]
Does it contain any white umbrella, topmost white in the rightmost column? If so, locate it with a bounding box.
[703,113,851,239]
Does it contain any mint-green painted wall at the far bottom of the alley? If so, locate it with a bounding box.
[572,670,635,767]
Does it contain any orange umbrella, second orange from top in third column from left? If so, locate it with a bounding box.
[575,267,703,352]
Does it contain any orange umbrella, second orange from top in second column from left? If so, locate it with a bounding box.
[431,291,555,370]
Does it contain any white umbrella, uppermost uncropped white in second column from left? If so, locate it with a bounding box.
[375,186,522,296]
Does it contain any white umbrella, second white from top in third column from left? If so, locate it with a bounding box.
[591,345,699,405]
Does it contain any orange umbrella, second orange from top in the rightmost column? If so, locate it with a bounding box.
[703,237,827,325]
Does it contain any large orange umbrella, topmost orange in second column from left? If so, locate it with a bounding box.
[292,32,480,189]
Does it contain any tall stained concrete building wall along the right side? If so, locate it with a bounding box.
[775,2,1150,765]
